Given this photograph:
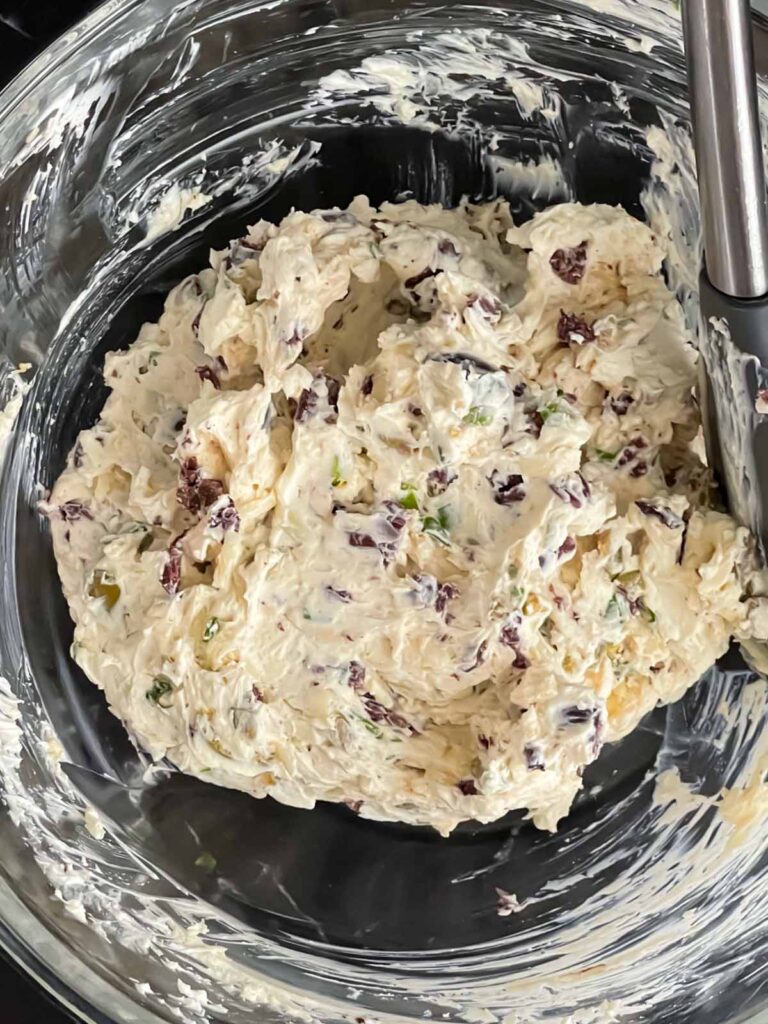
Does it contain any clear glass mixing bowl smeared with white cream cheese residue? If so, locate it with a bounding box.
[0,0,768,1024]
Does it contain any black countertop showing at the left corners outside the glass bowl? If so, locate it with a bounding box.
[0,0,96,1024]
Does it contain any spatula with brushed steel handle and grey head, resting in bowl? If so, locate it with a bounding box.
[682,0,768,551]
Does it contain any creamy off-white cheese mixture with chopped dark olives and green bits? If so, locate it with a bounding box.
[46,198,768,835]
